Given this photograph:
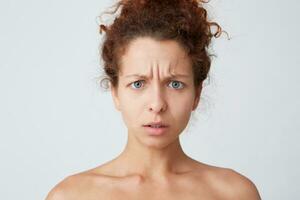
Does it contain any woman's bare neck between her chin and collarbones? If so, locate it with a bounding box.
[111,130,189,179]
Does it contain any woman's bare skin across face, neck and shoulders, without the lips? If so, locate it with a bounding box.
[46,37,260,200]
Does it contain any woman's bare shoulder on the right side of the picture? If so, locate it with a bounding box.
[200,166,261,200]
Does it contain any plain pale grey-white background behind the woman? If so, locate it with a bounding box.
[0,0,300,200]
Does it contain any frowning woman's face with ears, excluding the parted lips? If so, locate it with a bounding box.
[112,37,201,147]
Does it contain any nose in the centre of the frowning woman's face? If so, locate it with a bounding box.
[149,83,167,113]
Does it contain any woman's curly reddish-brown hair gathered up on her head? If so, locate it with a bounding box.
[99,0,229,90]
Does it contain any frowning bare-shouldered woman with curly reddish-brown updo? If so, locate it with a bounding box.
[47,0,260,200]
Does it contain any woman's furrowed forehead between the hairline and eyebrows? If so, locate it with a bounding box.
[120,37,192,76]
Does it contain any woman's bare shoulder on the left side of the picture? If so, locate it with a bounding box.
[46,171,108,200]
